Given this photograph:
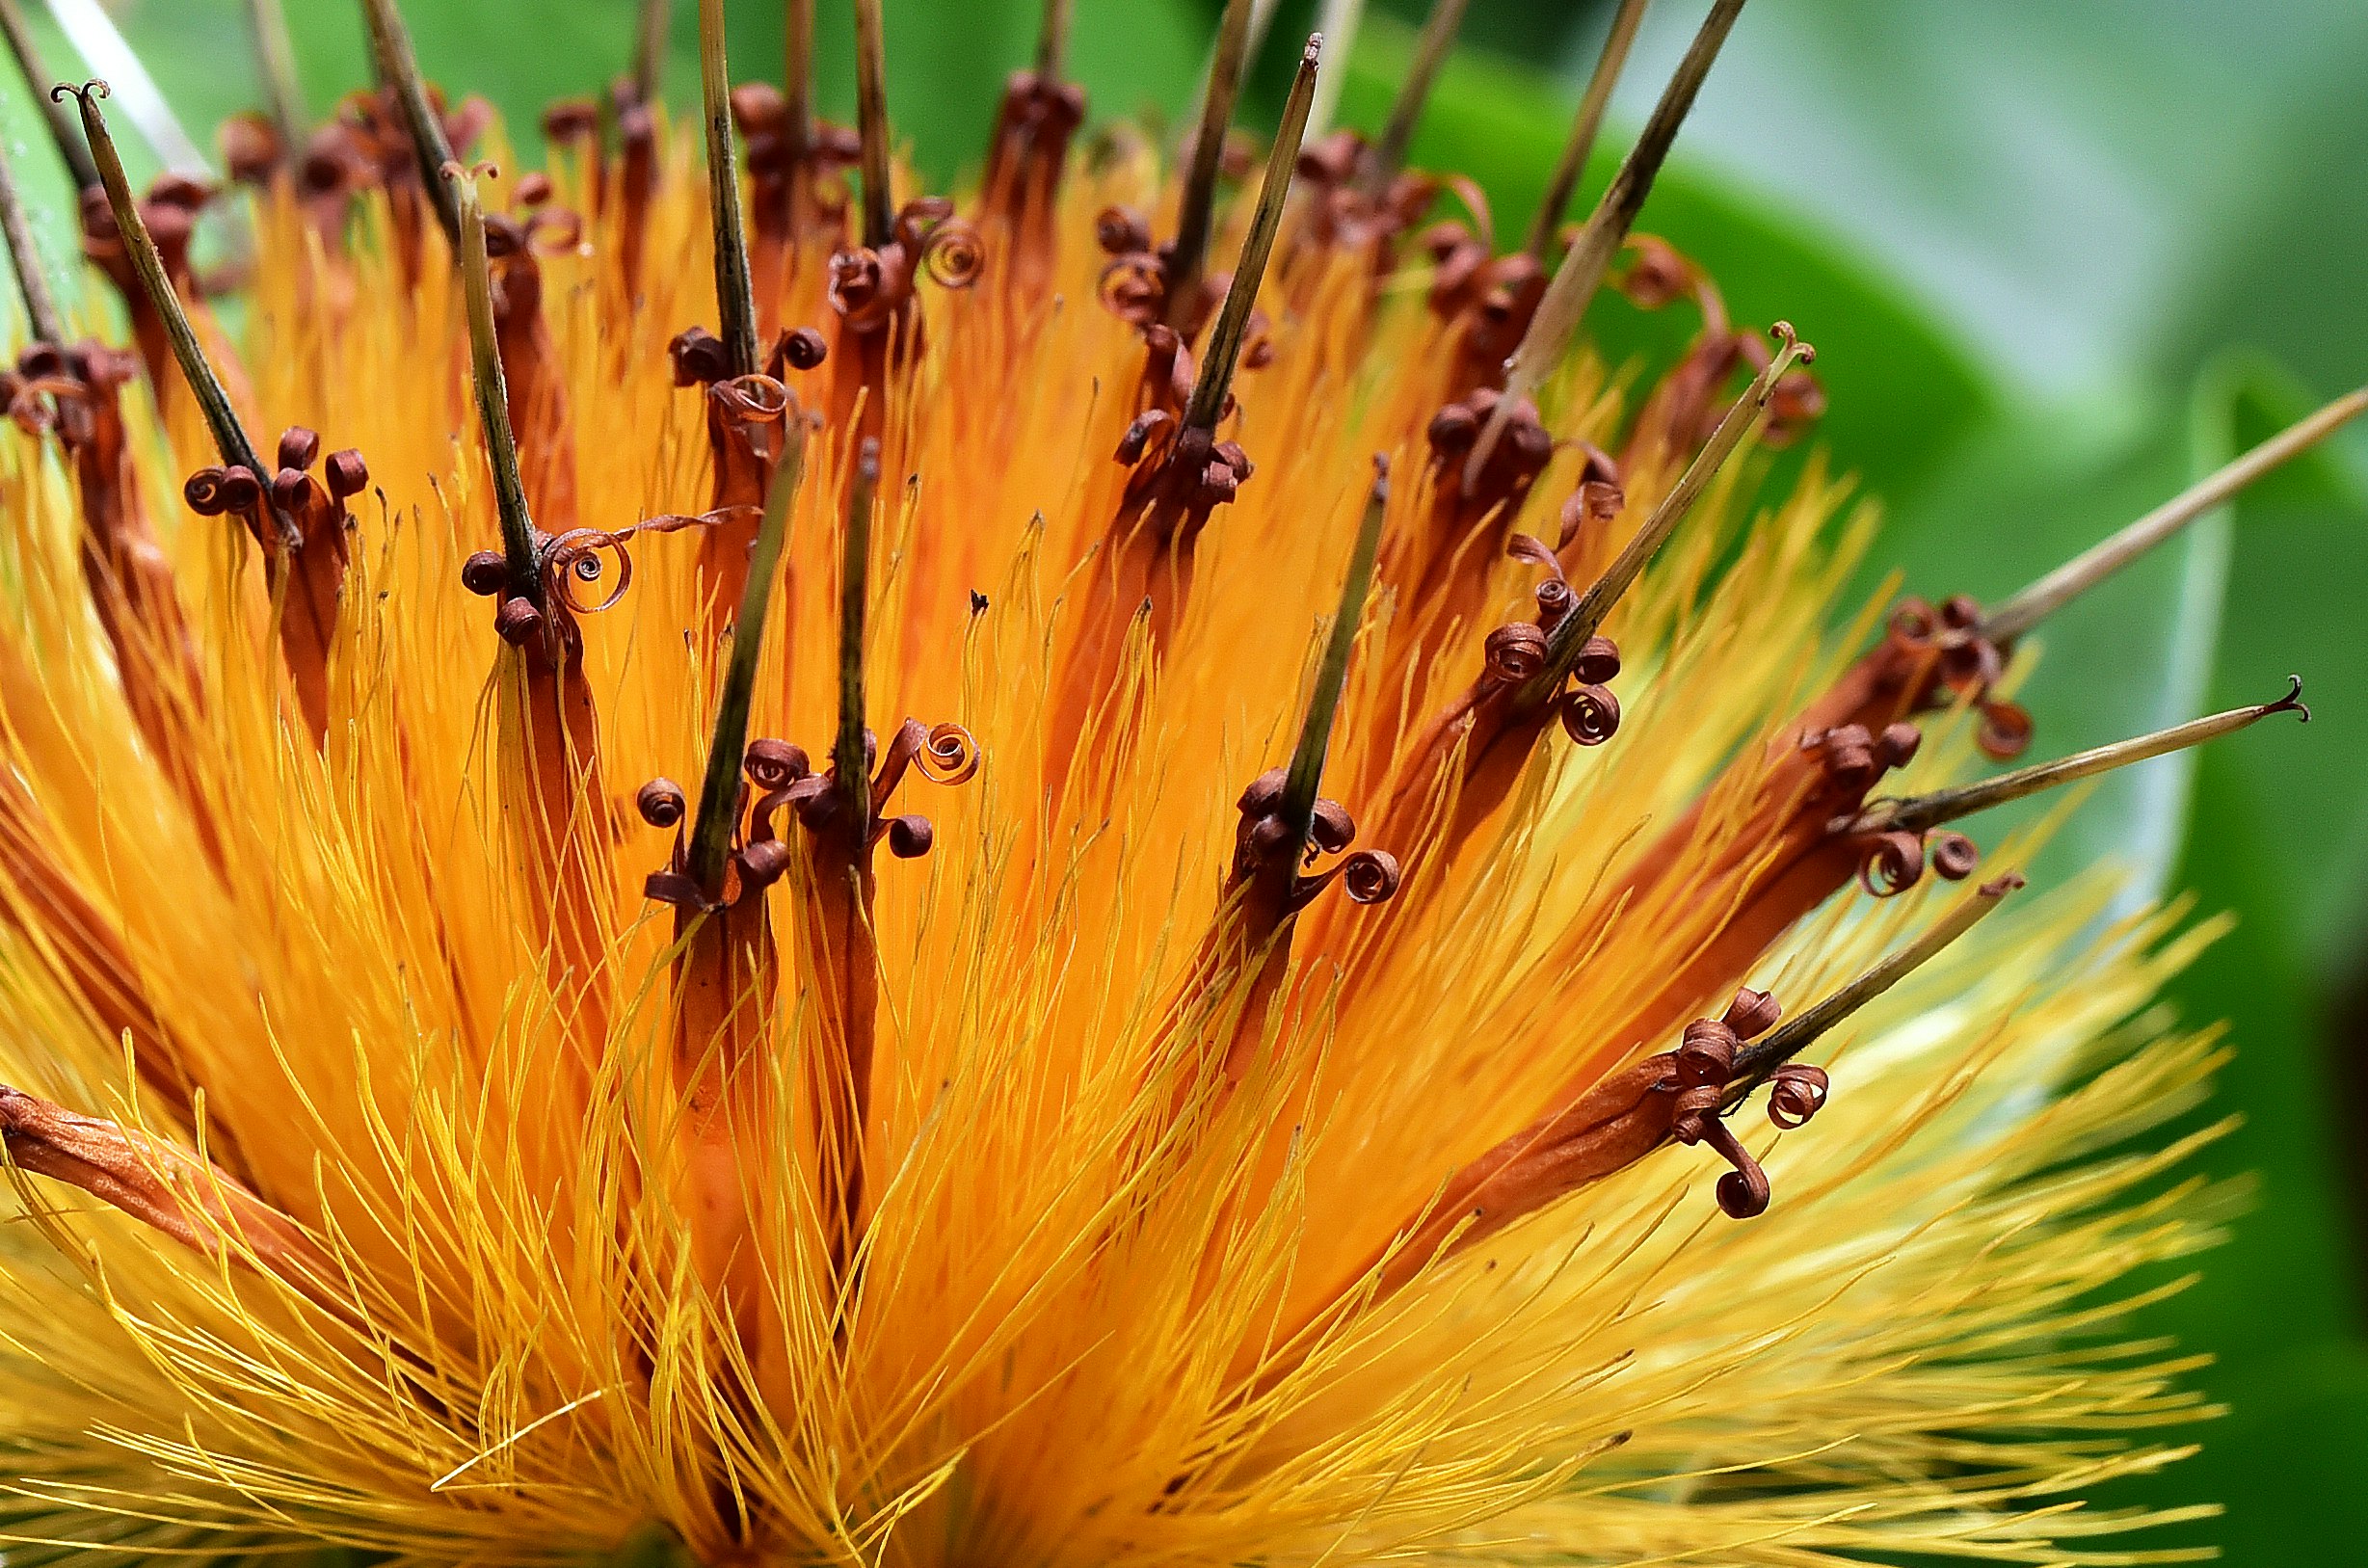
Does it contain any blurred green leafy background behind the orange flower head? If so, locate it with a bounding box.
[7,0,2368,1568]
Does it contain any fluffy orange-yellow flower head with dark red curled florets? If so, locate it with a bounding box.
[0,0,2363,1563]
